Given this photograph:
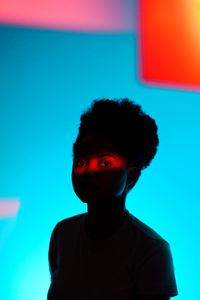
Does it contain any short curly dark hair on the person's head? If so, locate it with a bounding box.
[73,98,159,170]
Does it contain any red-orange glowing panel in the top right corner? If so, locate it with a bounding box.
[138,0,200,91]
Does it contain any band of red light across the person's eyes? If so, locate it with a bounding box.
[73,153,126,175]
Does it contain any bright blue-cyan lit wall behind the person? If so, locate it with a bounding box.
[0,17,200,300]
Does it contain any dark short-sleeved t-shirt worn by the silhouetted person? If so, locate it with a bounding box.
[47,210,178,300]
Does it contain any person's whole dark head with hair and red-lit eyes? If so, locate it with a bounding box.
[72,99,159,202]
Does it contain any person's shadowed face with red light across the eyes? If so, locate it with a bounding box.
[72,135,133,203]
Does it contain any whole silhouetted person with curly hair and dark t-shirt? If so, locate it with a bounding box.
[48,99,178,300]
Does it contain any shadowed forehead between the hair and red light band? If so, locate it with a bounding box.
[75,134,123,156]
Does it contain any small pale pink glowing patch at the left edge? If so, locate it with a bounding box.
[0,198,20,218]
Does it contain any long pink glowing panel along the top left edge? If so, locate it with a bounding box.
[0,0,133,32]
